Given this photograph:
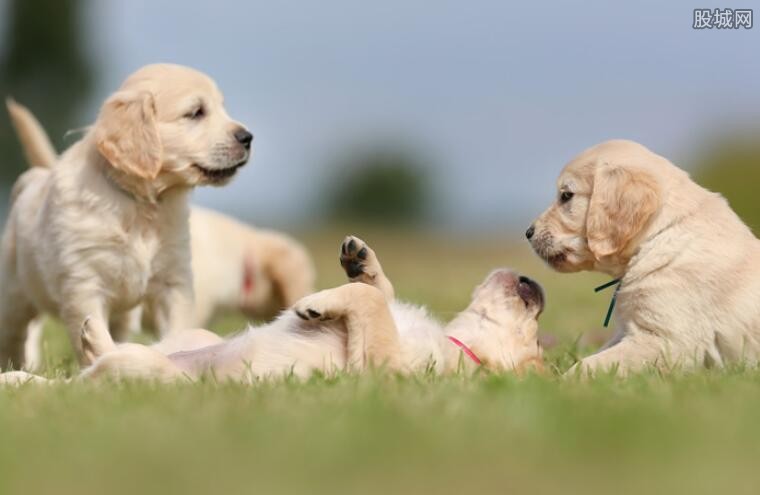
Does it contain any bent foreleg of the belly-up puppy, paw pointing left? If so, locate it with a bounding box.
[293,283,402,371]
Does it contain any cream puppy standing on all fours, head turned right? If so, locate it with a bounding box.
[0,64,253,367]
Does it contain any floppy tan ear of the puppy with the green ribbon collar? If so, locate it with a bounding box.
[586,164,660,260]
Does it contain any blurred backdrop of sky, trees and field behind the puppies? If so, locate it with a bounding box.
[0,0,760,356]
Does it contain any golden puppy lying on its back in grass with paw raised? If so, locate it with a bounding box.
[0,237,544,384]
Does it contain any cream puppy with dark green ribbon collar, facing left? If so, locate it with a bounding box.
[526,141,760,374]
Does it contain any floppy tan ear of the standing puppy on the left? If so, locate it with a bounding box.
[95,91,161,179]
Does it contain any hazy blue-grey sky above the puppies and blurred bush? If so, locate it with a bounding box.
[2,0,760,230]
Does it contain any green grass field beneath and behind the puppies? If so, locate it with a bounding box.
[0,232,760,494]
